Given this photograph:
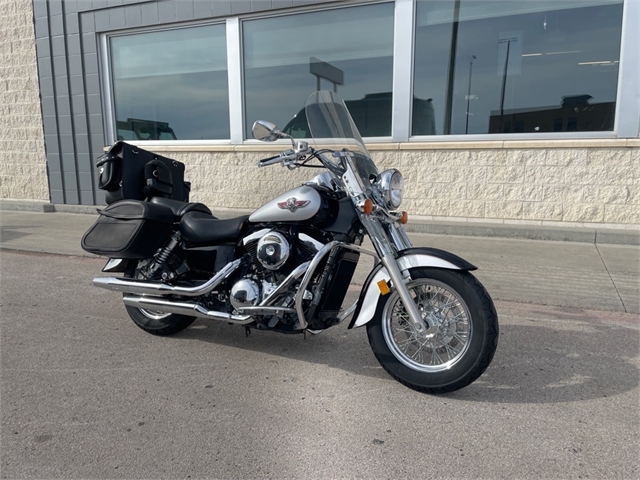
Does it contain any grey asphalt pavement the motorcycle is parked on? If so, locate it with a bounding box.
[0,253,640,479]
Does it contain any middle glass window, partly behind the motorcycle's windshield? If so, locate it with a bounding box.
[242,3,393,138]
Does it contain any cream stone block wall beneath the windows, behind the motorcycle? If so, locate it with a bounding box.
[154,140,640,229]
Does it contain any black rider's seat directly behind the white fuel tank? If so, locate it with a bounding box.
[180,211,249,244]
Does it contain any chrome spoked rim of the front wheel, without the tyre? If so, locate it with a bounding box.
[382,278,473,372]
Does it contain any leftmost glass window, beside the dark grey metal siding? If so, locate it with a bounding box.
[110,25,230,140]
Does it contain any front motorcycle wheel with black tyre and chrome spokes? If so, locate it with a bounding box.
[367,268,498,393]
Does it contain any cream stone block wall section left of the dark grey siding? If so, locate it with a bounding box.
[0,0,49,201]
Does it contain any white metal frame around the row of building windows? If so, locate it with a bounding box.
[98,0,640,147]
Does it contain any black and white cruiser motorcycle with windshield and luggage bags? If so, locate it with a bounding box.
[82,91,498,393]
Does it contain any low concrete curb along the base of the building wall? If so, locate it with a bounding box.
[0,200,640,245]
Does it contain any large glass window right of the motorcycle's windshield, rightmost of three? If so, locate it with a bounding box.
[412,0,622,135]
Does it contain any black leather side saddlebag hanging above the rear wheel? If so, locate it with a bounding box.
[82,200,173,259]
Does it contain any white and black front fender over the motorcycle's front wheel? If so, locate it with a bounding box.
[349,248,477,328]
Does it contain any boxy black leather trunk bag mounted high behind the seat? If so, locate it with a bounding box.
[96,142,190,204]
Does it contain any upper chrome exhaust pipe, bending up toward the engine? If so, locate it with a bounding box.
[93,258,242,297]
